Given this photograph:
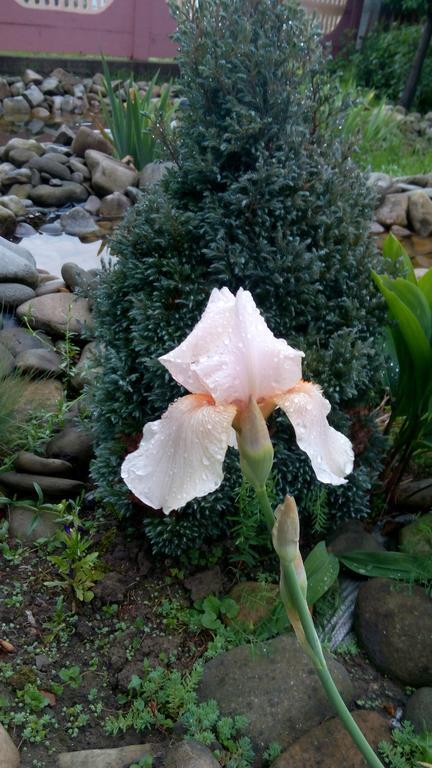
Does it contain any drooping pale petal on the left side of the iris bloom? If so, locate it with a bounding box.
[121,395,236,514]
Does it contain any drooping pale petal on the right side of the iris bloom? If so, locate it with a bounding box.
[275,381,354,485]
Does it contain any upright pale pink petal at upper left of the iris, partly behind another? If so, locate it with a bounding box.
[159,288,235,392]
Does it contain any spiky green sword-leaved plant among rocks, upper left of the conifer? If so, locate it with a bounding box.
[102,59,174,170]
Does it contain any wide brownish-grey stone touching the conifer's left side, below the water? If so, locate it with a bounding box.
[17,293,92,336]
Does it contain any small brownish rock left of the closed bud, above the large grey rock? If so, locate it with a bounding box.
[227,581,279,631]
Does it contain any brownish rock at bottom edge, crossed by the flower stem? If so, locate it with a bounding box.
[272,710,390,768]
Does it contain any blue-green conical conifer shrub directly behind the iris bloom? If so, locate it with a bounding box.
[93,0,384,553]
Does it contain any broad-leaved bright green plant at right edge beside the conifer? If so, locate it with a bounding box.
[373,235,432,497]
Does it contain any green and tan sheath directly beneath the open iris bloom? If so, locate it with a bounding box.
[235,398,273,488]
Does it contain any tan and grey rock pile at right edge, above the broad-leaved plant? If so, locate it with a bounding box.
[369,173,432,257]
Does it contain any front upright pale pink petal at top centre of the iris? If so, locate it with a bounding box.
[193,288,303,403]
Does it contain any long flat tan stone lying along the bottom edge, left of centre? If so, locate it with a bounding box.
[57,744,161,768]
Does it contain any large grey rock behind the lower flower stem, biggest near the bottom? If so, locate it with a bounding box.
[198,635,353,751]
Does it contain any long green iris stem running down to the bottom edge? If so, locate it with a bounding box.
[255,488,384,768]
